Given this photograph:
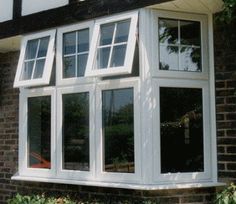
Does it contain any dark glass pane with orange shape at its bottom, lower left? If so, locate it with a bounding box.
[28,96,51,169]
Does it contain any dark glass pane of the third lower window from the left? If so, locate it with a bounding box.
[102,88,134,173]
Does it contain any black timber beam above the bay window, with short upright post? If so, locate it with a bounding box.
[0,0,171,39]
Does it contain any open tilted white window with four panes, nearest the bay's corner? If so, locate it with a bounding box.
[85,11,138,76]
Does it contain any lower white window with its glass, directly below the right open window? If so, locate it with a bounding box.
[95,78,141,183]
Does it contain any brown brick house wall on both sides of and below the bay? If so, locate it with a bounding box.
[0,16,236,204]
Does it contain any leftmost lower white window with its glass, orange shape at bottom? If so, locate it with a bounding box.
[19,87,56,178]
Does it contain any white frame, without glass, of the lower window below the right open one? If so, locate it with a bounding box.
[96,79,142,183]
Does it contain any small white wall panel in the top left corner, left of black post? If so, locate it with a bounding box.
[0,0,13,22]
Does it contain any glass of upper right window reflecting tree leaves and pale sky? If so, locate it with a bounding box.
[159,19,202,72]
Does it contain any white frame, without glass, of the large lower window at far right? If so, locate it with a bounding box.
[153,79,212,183]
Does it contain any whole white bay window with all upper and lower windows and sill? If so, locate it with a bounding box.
[14,9,216,189]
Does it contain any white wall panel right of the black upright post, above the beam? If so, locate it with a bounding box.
[21,0,69,16]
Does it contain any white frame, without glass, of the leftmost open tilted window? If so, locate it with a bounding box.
[14,29,56,87]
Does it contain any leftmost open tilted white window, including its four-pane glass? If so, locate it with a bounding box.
[14,30,56,87]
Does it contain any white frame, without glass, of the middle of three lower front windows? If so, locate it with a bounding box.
[55,84,95,180]
